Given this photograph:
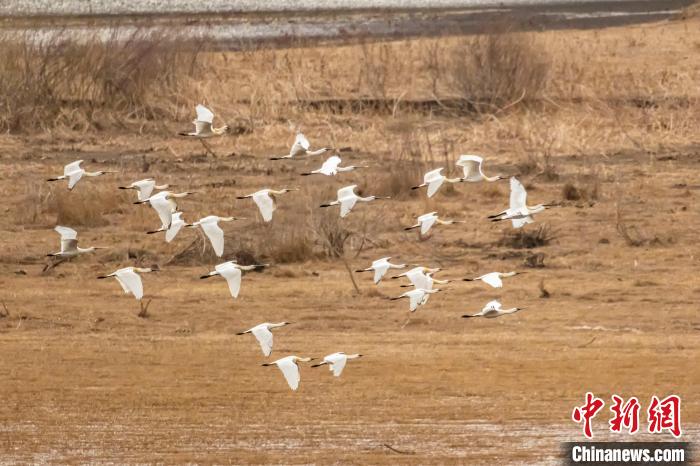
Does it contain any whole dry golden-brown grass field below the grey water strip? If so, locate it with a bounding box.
[0,12,700,464]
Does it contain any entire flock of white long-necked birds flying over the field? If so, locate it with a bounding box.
[43,105,553,390]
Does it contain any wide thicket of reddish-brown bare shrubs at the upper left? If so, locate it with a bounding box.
[0,30,202,132]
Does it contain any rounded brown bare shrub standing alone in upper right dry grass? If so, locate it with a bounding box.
[446,27,550,110]
